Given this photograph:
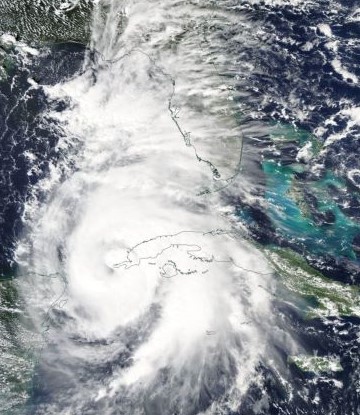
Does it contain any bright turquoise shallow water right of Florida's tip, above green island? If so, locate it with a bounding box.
[262,160,359,260]
